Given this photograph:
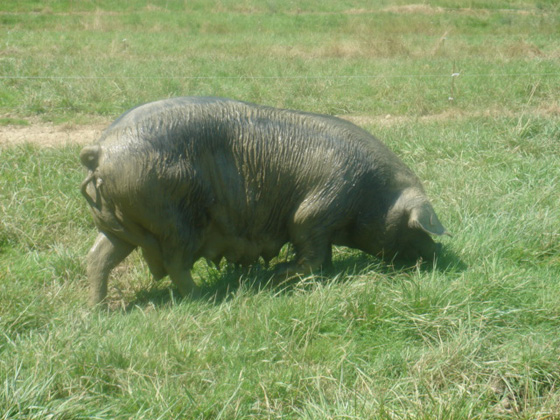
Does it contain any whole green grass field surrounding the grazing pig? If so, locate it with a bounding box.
[0,0,560,420]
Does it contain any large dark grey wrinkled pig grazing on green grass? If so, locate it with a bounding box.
[80,97,448,305]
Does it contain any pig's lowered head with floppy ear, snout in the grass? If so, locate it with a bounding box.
[355,187,451,261]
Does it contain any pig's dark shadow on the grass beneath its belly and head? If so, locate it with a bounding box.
[128,246,468,308]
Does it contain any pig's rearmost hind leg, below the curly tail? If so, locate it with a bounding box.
[87,232,136,306]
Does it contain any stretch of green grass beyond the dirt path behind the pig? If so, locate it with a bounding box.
[0,1,560,122]
